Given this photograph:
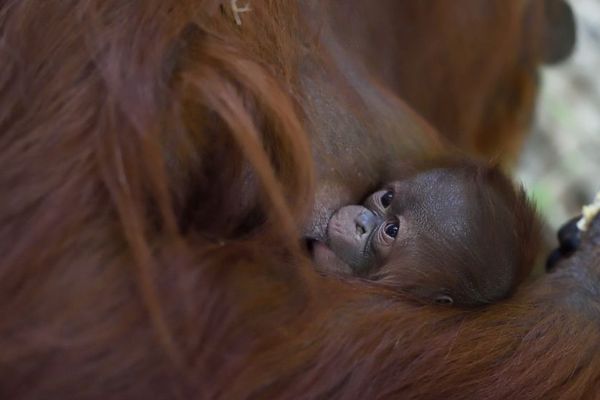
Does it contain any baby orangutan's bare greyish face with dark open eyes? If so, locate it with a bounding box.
[314,169,471,276]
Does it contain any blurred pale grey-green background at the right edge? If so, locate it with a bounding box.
[517,0,600,228]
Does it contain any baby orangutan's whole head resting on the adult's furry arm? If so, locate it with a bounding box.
[313,160,541,306]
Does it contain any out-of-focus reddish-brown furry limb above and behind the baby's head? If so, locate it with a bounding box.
[327,0,568,161]
